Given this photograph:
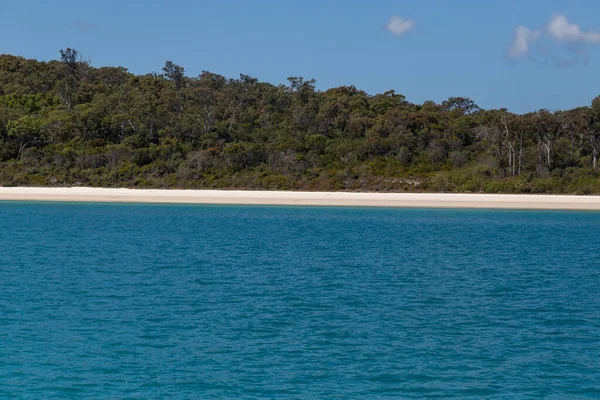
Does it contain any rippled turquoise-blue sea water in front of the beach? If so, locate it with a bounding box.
[0,203,600,399]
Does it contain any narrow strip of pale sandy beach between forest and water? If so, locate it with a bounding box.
[0,187,600,210]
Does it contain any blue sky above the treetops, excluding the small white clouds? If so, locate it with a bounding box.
[0,0,600,112]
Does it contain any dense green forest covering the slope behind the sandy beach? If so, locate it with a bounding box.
[0,49,600,194]
